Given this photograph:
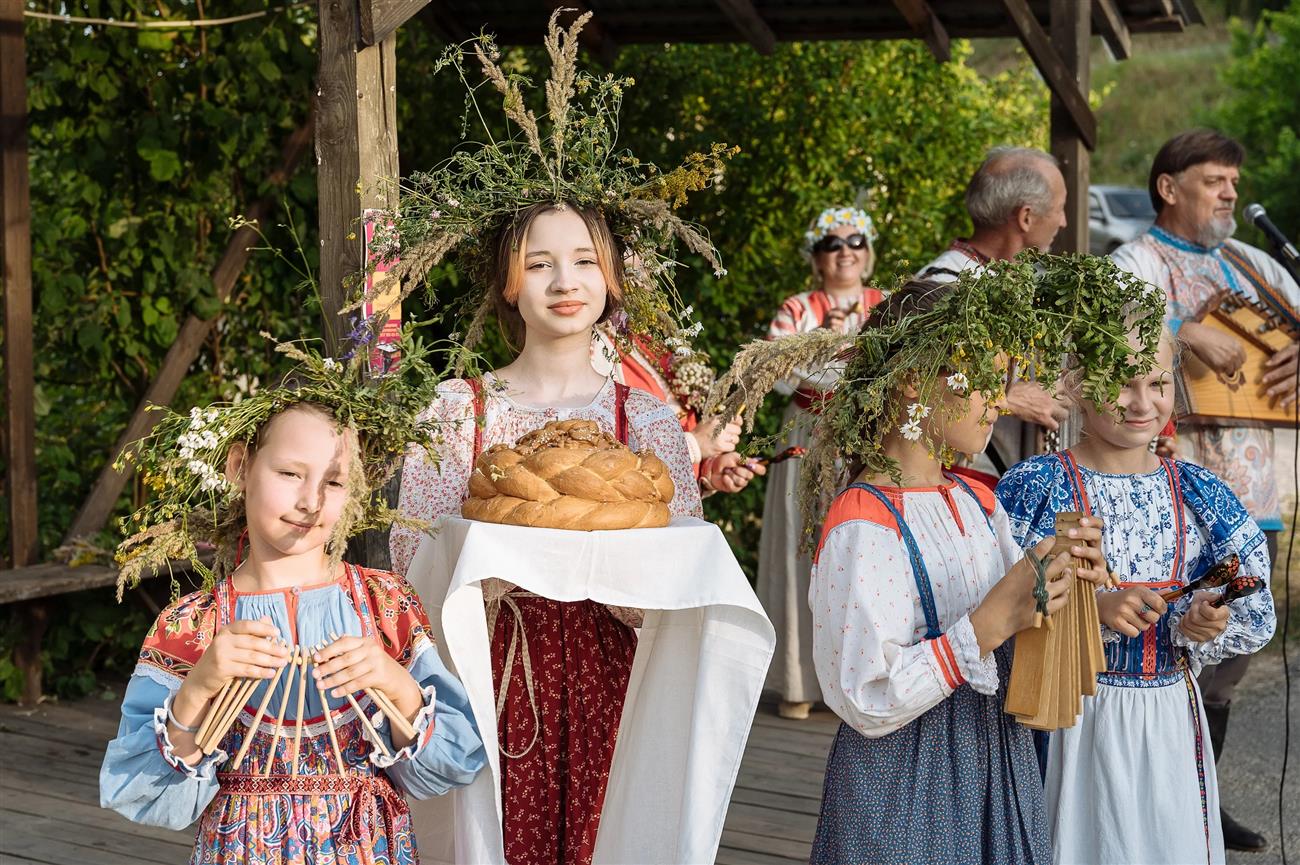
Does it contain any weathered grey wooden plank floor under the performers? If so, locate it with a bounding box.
[0,700,837,865]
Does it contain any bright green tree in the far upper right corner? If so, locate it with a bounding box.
[1208,0,1300,246]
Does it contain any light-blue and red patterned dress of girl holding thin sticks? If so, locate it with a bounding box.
[100,566,486,865]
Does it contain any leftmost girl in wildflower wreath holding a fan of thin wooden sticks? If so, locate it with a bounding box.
[100,332,484,865]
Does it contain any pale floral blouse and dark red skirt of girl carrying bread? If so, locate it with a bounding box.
[391,377,701,865]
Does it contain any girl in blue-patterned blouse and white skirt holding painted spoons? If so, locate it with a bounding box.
[997,334,1274,864]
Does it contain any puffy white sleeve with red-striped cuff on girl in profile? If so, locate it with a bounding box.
[809,520,982,739]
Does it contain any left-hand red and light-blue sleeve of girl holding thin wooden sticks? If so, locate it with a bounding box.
[99,593,228,830]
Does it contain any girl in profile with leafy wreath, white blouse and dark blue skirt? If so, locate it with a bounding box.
[716,256,1153,864]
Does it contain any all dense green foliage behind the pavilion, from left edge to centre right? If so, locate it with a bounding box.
[0,16,1047,693]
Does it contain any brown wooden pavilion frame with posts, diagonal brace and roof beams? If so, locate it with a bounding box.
[0,0,1203,701]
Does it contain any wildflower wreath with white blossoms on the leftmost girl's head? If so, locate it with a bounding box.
[116,324,439,600]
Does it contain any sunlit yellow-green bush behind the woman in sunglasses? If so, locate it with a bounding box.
[614,35,1048,574]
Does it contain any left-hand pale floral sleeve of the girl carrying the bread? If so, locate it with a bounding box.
[389,380,475,574]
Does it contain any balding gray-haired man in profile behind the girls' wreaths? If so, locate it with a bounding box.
[917,147,1070,475]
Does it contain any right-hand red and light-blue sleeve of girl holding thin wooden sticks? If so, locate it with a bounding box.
[363,571,488,799]
